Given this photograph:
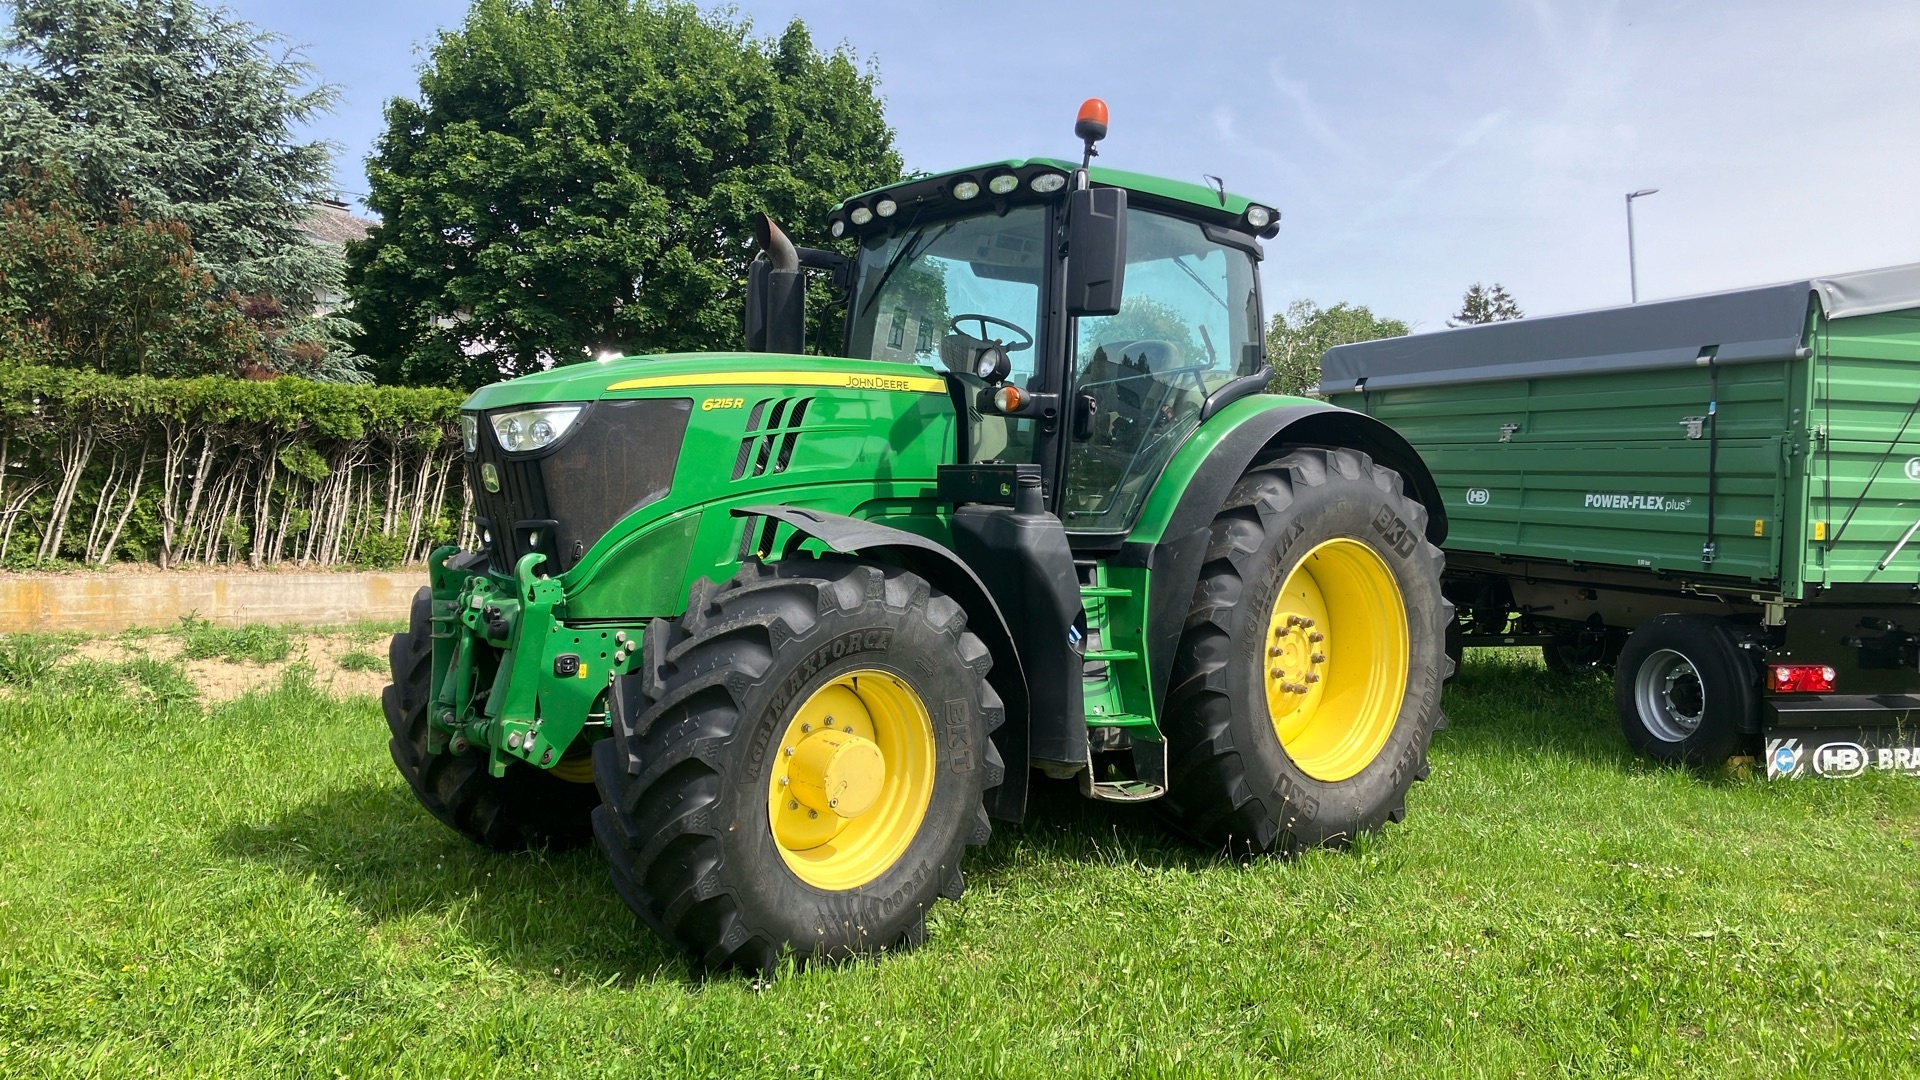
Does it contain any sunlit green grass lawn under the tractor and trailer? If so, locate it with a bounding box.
[0,641,1920,1076]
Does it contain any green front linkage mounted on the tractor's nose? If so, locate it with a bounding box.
[428,546,641,780]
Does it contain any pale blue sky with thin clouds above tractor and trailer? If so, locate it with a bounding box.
[227,0,1920,332]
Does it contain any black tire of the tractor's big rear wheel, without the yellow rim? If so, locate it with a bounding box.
[1162,448,1453,855]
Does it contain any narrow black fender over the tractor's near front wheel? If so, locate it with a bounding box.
[733,505,1036,824]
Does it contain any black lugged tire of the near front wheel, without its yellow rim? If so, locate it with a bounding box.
[593,555,1004,970]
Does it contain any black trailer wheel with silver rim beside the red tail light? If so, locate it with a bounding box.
[1613,615,1759,765]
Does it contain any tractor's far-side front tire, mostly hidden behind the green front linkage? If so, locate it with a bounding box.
[380,588,599,851]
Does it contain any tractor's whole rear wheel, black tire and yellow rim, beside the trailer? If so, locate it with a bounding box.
[1162,448,1453,855]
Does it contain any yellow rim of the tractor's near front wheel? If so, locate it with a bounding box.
[766,671,935,892]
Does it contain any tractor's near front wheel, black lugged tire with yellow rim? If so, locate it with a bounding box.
[593,555,1004,970]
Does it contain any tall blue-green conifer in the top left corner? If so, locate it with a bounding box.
[0,0,340,307]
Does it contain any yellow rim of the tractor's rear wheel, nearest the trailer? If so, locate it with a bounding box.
[1261,538,1407,784]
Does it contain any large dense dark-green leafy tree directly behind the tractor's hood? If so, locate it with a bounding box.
[348,0,900,386]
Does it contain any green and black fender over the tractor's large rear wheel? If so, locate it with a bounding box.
[1114,394,1446,715]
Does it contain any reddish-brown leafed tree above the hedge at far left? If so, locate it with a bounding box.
[0,165,263,375]
